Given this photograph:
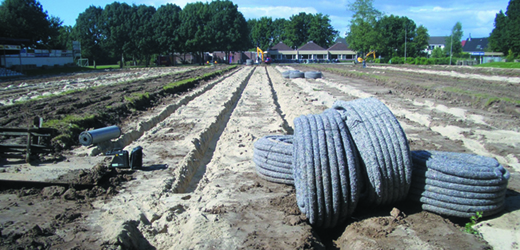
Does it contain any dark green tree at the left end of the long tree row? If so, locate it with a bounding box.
[73,6,106,68]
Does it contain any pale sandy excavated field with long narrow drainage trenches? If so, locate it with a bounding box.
[0,64,520,249]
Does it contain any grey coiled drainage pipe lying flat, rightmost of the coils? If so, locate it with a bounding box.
[409,151,510,218]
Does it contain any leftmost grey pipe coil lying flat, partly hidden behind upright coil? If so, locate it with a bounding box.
[253,135,294,185]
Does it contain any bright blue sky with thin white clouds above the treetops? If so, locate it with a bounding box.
[39,0,509,39]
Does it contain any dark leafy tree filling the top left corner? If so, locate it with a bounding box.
[0,0,57,48]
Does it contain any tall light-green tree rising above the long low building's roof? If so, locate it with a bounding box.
[347,0,382,54]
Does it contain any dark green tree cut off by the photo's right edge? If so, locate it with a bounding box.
[504,0,520,56]
